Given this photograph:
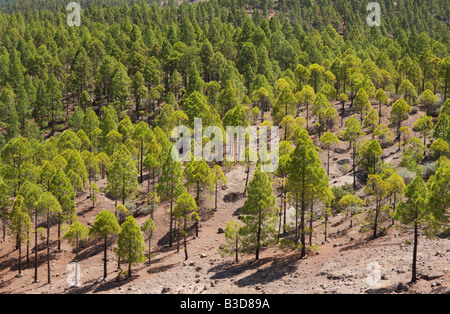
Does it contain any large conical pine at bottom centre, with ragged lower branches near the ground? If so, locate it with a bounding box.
[240,168,278,260]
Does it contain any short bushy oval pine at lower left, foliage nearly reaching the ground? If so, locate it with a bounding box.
[118,216,145,278]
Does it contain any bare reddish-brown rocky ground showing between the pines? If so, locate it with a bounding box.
[0,97,450,294]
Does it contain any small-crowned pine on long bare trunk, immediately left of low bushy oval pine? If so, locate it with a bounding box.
[89,210,120,281]
